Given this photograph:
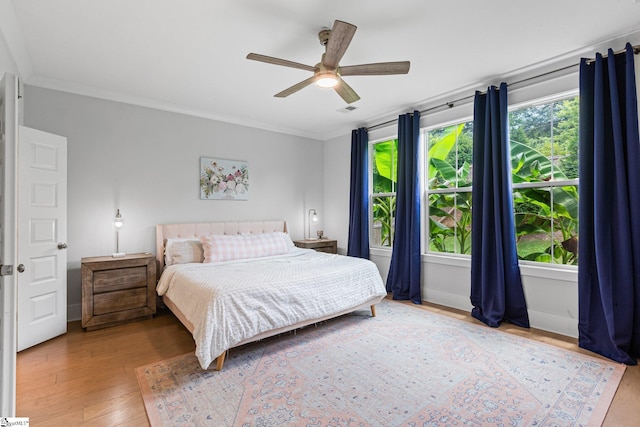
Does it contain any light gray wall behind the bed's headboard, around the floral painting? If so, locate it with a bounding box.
[24,86,323,319]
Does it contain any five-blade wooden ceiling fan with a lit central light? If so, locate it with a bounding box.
[247,20,410,104]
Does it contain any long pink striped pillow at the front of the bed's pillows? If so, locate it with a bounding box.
[200,232,289,262]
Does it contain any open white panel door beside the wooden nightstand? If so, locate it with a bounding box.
[16,126,67,351]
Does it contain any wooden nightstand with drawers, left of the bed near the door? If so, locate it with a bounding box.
[81,253,156,331]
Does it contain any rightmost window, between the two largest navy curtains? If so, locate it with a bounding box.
[509,97,578,265]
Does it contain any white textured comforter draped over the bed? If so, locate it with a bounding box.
[157,249,386,369]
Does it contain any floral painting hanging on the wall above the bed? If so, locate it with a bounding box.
[200,157,249,200]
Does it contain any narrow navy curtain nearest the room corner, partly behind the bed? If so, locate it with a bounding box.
[347,128,369,259]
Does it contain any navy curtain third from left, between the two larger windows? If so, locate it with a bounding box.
[471,83,529,328]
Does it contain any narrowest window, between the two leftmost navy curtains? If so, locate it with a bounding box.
[370,139,398,247]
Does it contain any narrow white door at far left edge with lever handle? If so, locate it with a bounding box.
[0,74,18,417]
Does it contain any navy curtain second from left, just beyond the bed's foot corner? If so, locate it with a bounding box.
[387,111,422,304]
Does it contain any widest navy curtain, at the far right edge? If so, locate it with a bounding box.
[578,44,640,365]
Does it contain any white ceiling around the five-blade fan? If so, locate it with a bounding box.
[0,0,640,140]
